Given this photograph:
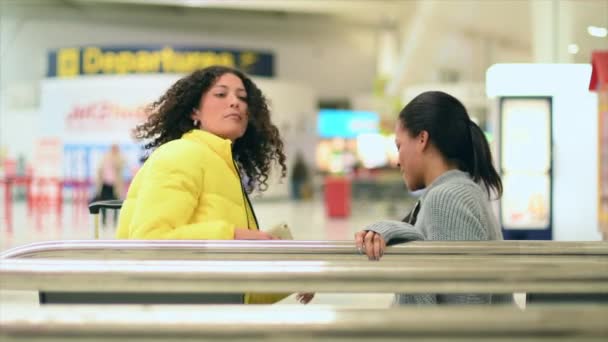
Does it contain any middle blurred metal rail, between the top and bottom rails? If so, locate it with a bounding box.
[0,256,608,293]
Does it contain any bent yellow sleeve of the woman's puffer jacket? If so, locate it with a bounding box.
[129,146,235,240]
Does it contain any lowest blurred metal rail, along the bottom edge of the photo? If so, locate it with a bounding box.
[0,305,608,341]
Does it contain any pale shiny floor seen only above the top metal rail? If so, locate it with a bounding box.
[0,199,413,251]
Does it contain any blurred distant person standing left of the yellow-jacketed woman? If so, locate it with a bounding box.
[95,144,125,225]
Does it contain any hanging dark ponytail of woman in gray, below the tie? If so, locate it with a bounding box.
[466,121,502,198]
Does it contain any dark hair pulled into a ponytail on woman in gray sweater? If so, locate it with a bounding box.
[399,91,502,197]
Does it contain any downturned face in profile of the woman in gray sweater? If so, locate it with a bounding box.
[395,120,425,191]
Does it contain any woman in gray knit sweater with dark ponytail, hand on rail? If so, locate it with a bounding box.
[355,91,510,304]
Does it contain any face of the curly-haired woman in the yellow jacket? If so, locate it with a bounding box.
[192,73,249,141]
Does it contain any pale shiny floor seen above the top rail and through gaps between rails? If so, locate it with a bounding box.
[0,199,413,310]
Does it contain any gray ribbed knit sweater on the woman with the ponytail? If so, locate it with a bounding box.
[365,170,511,305]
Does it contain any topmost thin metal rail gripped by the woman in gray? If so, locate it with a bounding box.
[0,240,608,259]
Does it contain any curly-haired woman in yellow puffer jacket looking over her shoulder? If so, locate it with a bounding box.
[116,66,312,303]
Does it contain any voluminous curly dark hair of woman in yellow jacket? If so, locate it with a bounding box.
[133,66,287,191]
